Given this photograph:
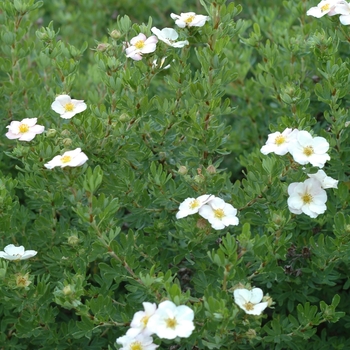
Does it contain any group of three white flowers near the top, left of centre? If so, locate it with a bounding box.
[125,12,209,61]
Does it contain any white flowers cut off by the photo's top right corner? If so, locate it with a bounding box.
[306,0,350,25]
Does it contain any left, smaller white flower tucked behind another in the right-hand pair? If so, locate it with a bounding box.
[260,128,299,156]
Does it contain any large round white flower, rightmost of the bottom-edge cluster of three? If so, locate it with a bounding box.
[148,300,194,339]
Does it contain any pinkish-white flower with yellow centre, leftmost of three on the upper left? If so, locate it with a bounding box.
[6,118,45,141]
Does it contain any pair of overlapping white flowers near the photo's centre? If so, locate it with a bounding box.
[176,194,239,230]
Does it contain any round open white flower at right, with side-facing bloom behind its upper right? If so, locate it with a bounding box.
[288,178,327,218]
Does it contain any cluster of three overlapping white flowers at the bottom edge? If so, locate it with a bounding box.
[117,300,194,350]
